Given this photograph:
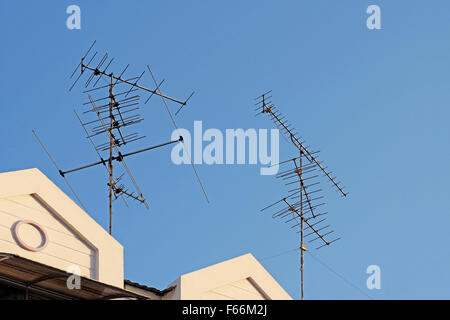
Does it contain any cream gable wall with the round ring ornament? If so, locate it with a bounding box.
[0,169,124,288]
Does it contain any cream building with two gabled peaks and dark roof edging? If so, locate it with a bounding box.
[0,169,291,300]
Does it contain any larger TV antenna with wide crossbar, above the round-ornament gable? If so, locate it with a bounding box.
[33,41,209,234]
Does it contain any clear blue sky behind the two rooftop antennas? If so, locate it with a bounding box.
[0,0,450,299]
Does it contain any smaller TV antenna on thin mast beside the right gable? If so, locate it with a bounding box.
[255,91,348,300]
